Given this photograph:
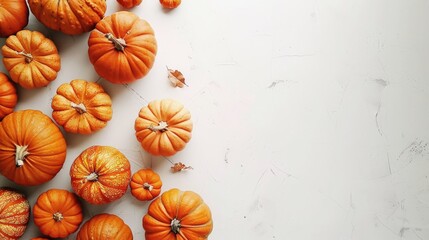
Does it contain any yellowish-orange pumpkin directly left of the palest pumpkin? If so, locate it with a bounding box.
[51,79,112,134]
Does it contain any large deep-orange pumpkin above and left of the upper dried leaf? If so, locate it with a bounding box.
[88,11,157,83]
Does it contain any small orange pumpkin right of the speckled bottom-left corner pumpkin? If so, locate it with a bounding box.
[33,189,83,238]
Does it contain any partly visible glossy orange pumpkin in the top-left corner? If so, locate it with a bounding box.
[0,0,29,37]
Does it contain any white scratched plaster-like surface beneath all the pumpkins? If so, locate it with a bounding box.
[0,0,429,240]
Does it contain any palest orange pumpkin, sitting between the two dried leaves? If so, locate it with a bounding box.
[134,99,192,156]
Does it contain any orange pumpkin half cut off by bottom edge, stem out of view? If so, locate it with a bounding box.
[76,213,131,240]
